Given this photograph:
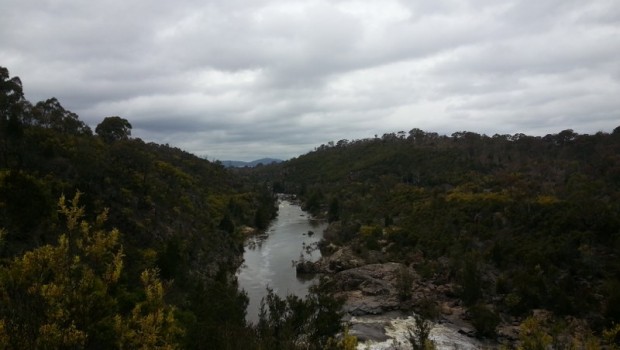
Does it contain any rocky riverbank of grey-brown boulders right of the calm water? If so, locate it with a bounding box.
[298,246,518,349]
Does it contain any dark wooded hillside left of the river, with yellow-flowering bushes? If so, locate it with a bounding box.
[0,68,290,349]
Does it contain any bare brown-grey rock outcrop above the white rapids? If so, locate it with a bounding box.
[308,244,518,349]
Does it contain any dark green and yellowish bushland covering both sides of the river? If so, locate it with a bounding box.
[0,67,620,349]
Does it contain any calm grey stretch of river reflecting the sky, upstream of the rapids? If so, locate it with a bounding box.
[237,197,327,323]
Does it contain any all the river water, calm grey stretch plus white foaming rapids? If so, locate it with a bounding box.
[237,197,482,350]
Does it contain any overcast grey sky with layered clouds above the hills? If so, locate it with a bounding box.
[0,0,620,160]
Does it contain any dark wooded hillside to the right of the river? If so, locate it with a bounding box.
[256,127,620,348]
